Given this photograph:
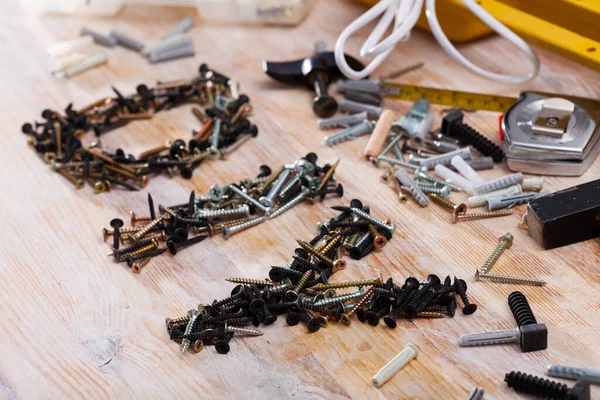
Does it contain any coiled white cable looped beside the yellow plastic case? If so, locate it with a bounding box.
[335,0,540,84]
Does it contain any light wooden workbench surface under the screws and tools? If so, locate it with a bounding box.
[0,0,600,399]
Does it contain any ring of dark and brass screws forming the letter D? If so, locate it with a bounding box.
[22,64,258,193]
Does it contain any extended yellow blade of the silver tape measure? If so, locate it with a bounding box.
[382,82,519,113]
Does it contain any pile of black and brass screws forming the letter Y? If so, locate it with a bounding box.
[166,203,477,353]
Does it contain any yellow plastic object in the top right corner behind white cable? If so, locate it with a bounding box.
[358,0,600,71]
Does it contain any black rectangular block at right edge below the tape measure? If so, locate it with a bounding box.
[525,179,600,249]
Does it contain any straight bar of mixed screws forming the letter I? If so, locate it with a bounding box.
[102,153,342,273]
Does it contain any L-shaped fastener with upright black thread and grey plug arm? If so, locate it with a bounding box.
[460,292,548,353]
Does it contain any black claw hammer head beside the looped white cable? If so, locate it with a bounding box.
[263,45,362,118]
